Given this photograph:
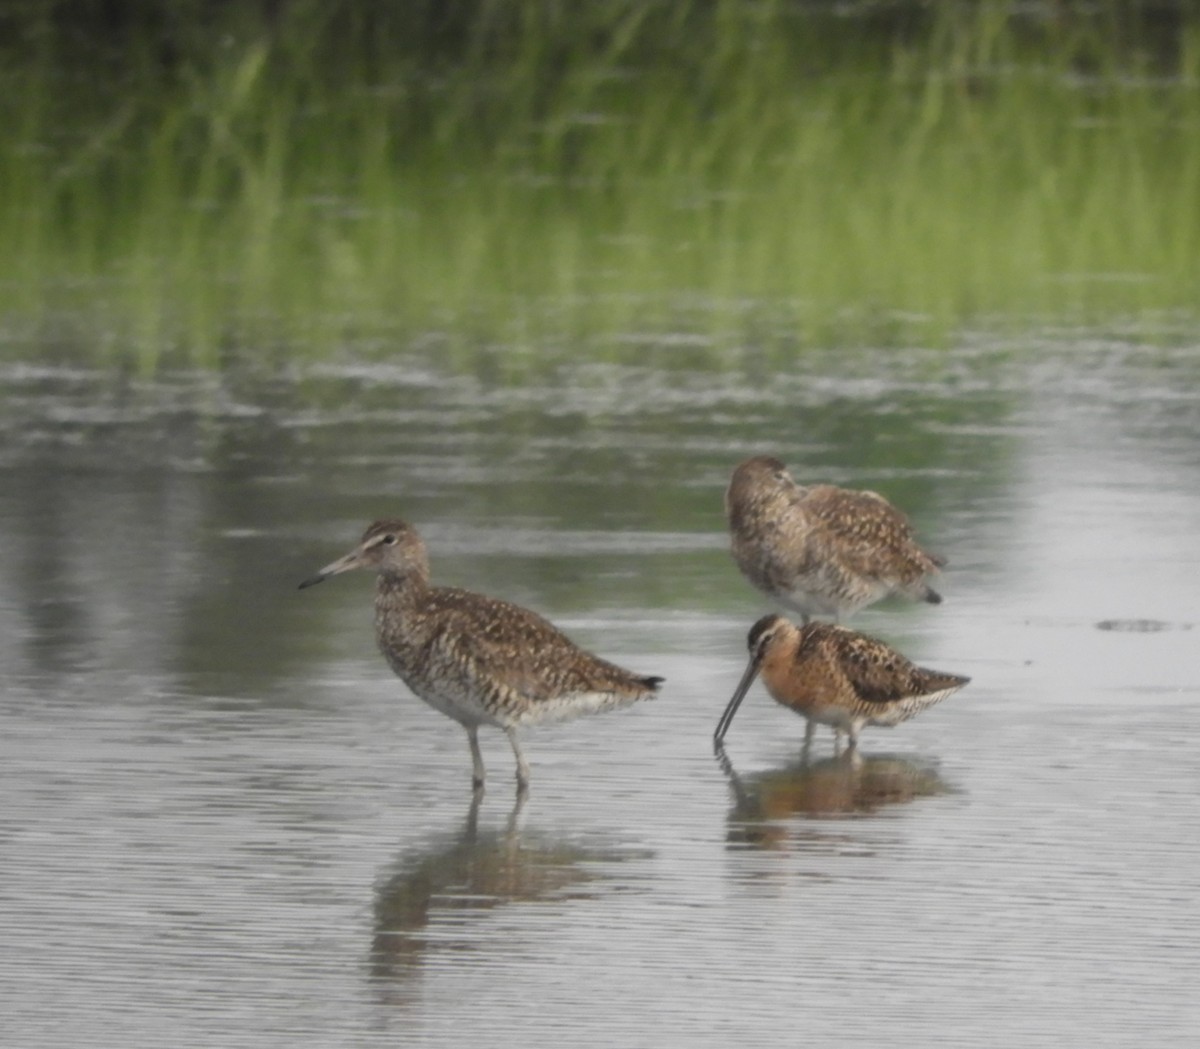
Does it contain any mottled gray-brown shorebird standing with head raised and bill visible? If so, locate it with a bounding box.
[300,518,662,789]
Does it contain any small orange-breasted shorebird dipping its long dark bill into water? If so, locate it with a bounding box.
[713,616,971,749]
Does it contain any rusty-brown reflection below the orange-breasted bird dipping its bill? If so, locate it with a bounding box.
[715,747,952,849]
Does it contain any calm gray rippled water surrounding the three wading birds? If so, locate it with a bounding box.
[0,337,1200,1049]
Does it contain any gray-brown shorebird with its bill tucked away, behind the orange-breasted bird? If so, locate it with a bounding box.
[725,455,943,623]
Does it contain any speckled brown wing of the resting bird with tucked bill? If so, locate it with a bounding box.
[804,485,938,576]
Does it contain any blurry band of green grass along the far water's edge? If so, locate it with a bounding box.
[0,0,1200,370]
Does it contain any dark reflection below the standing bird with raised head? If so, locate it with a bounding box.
[371,792,649,999]
